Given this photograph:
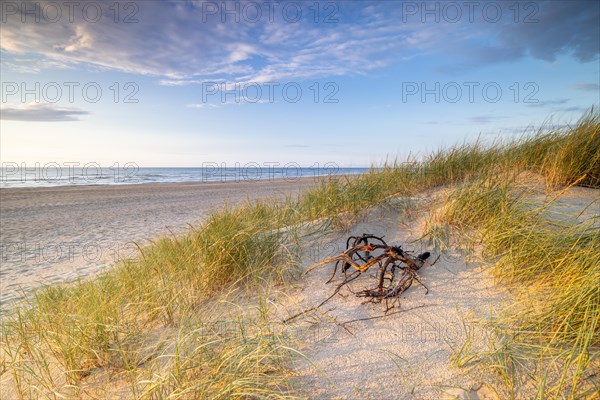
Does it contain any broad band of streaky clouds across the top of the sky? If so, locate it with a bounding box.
[1,0,600,85]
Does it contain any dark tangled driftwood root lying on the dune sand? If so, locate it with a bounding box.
[286,234,437,322]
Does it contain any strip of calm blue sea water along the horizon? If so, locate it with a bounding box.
[0,164,368,189]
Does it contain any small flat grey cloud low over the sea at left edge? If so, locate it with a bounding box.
[0,103,90,122]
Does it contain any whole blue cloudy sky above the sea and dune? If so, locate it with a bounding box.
[0,0,600,167]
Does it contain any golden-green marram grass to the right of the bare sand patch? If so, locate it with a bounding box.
[430,175,600,398]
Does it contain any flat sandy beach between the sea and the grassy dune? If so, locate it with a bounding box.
[0,178,315,306]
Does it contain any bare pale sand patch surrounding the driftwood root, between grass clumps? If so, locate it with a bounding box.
[272,203,504,399]
